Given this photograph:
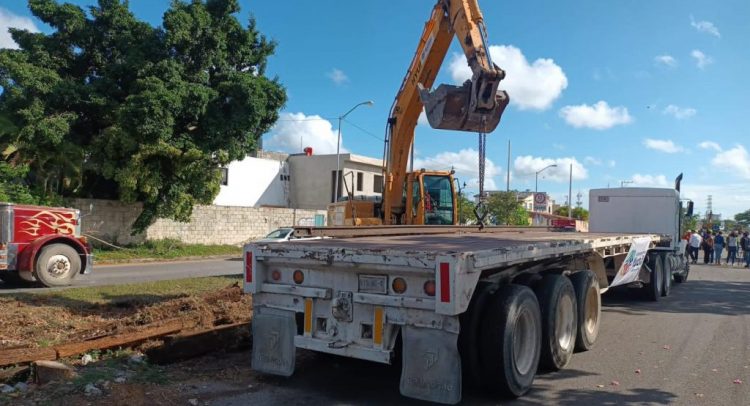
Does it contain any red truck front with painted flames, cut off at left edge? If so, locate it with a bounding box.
[0,203,93,287]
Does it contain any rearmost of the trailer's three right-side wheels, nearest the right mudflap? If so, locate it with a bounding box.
[479,285,542,397]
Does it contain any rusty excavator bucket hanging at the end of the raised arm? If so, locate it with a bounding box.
[419,81,509,133]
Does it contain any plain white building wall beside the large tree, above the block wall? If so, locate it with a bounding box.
[214,157,289,207]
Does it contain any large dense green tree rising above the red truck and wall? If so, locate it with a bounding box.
[0,0,286,231]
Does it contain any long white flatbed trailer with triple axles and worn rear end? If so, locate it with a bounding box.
[244,226,671,404]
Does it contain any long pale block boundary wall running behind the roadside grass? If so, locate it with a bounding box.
[71,199,326,245]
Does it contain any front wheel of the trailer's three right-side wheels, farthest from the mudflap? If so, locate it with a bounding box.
[570,270,602,351]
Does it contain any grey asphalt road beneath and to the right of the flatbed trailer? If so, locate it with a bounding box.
[211,266,750,406]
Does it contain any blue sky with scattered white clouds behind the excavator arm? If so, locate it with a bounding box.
[0,0,750,217]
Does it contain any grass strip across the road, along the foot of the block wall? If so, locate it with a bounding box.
[94,239,242,263]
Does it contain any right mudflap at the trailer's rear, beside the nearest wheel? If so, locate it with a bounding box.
[401,326,461,404]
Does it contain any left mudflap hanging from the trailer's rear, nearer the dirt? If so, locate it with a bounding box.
[252,307,297,376]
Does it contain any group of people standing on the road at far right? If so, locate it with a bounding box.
[683,230,750,268]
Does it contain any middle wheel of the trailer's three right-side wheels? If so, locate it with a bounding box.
[535,275,578,371]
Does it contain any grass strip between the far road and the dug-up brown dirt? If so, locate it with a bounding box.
[24,274,242,304]
